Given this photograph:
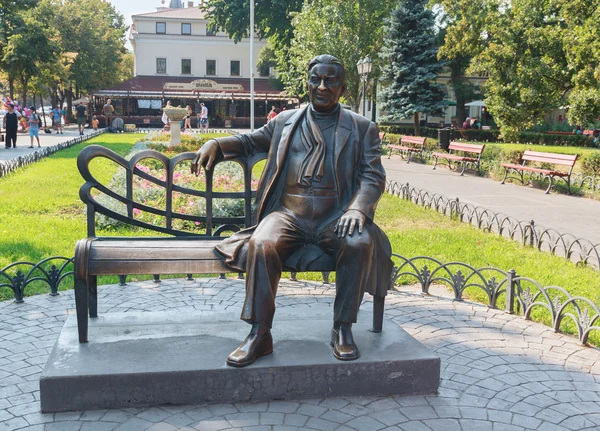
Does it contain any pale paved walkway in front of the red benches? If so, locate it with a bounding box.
[383,156,600,244]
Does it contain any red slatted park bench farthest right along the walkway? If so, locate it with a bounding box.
[500,150,578,194]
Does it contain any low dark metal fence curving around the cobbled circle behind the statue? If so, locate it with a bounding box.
[0,254,600,344]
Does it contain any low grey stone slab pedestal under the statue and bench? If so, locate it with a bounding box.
[40,305,440,412]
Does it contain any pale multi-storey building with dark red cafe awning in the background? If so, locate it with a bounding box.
[94,0,298,127]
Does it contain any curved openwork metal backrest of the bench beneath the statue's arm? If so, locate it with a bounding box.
[77,145,266,238]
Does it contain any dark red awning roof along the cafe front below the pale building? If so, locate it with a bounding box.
[98,76,281,94]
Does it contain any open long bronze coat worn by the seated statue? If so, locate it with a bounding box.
[212,107,393,296]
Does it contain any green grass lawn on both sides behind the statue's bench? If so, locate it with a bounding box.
[0,134,600,341]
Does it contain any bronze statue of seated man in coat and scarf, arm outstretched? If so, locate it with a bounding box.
[192,55,393,367]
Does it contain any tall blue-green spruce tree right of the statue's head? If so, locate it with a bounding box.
[380,0,445,136]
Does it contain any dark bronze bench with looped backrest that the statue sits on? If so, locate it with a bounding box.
[74,145,385,343]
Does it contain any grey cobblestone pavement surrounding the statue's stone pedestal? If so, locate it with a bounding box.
[0,279,600,431]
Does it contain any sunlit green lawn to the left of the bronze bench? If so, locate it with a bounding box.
[0,133,143,268]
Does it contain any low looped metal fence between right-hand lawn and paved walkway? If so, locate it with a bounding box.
[386,181,600,269]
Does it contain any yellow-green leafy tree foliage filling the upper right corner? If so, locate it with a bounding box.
[437,0,600,141]
